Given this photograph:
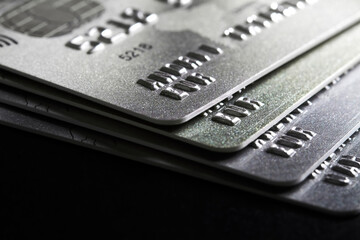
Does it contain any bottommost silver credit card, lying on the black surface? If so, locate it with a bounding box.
[0,104,360,215]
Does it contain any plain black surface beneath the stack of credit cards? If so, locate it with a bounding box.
[0,126,360,239]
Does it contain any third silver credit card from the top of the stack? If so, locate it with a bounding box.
[0,62,360,186]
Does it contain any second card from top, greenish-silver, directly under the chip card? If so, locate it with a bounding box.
[0,21,360,152]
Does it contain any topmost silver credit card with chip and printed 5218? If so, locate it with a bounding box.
[0,0,360,125]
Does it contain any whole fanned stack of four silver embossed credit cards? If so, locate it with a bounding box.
[0,0,360,214]
